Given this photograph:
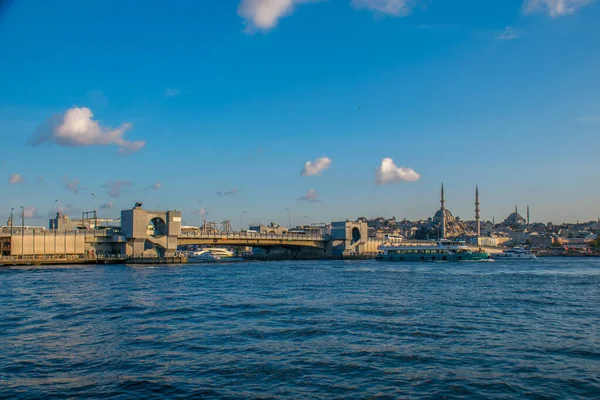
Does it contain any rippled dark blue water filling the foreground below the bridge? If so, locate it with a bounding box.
[0,259,600,399]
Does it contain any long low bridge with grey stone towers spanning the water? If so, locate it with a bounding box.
[0,203,372,257]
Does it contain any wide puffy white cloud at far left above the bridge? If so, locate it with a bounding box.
[30,107,146,154]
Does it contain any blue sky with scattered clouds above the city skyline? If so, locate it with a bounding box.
[0,0,600,227]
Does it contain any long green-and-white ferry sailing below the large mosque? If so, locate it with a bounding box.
[376,240,490,262]
